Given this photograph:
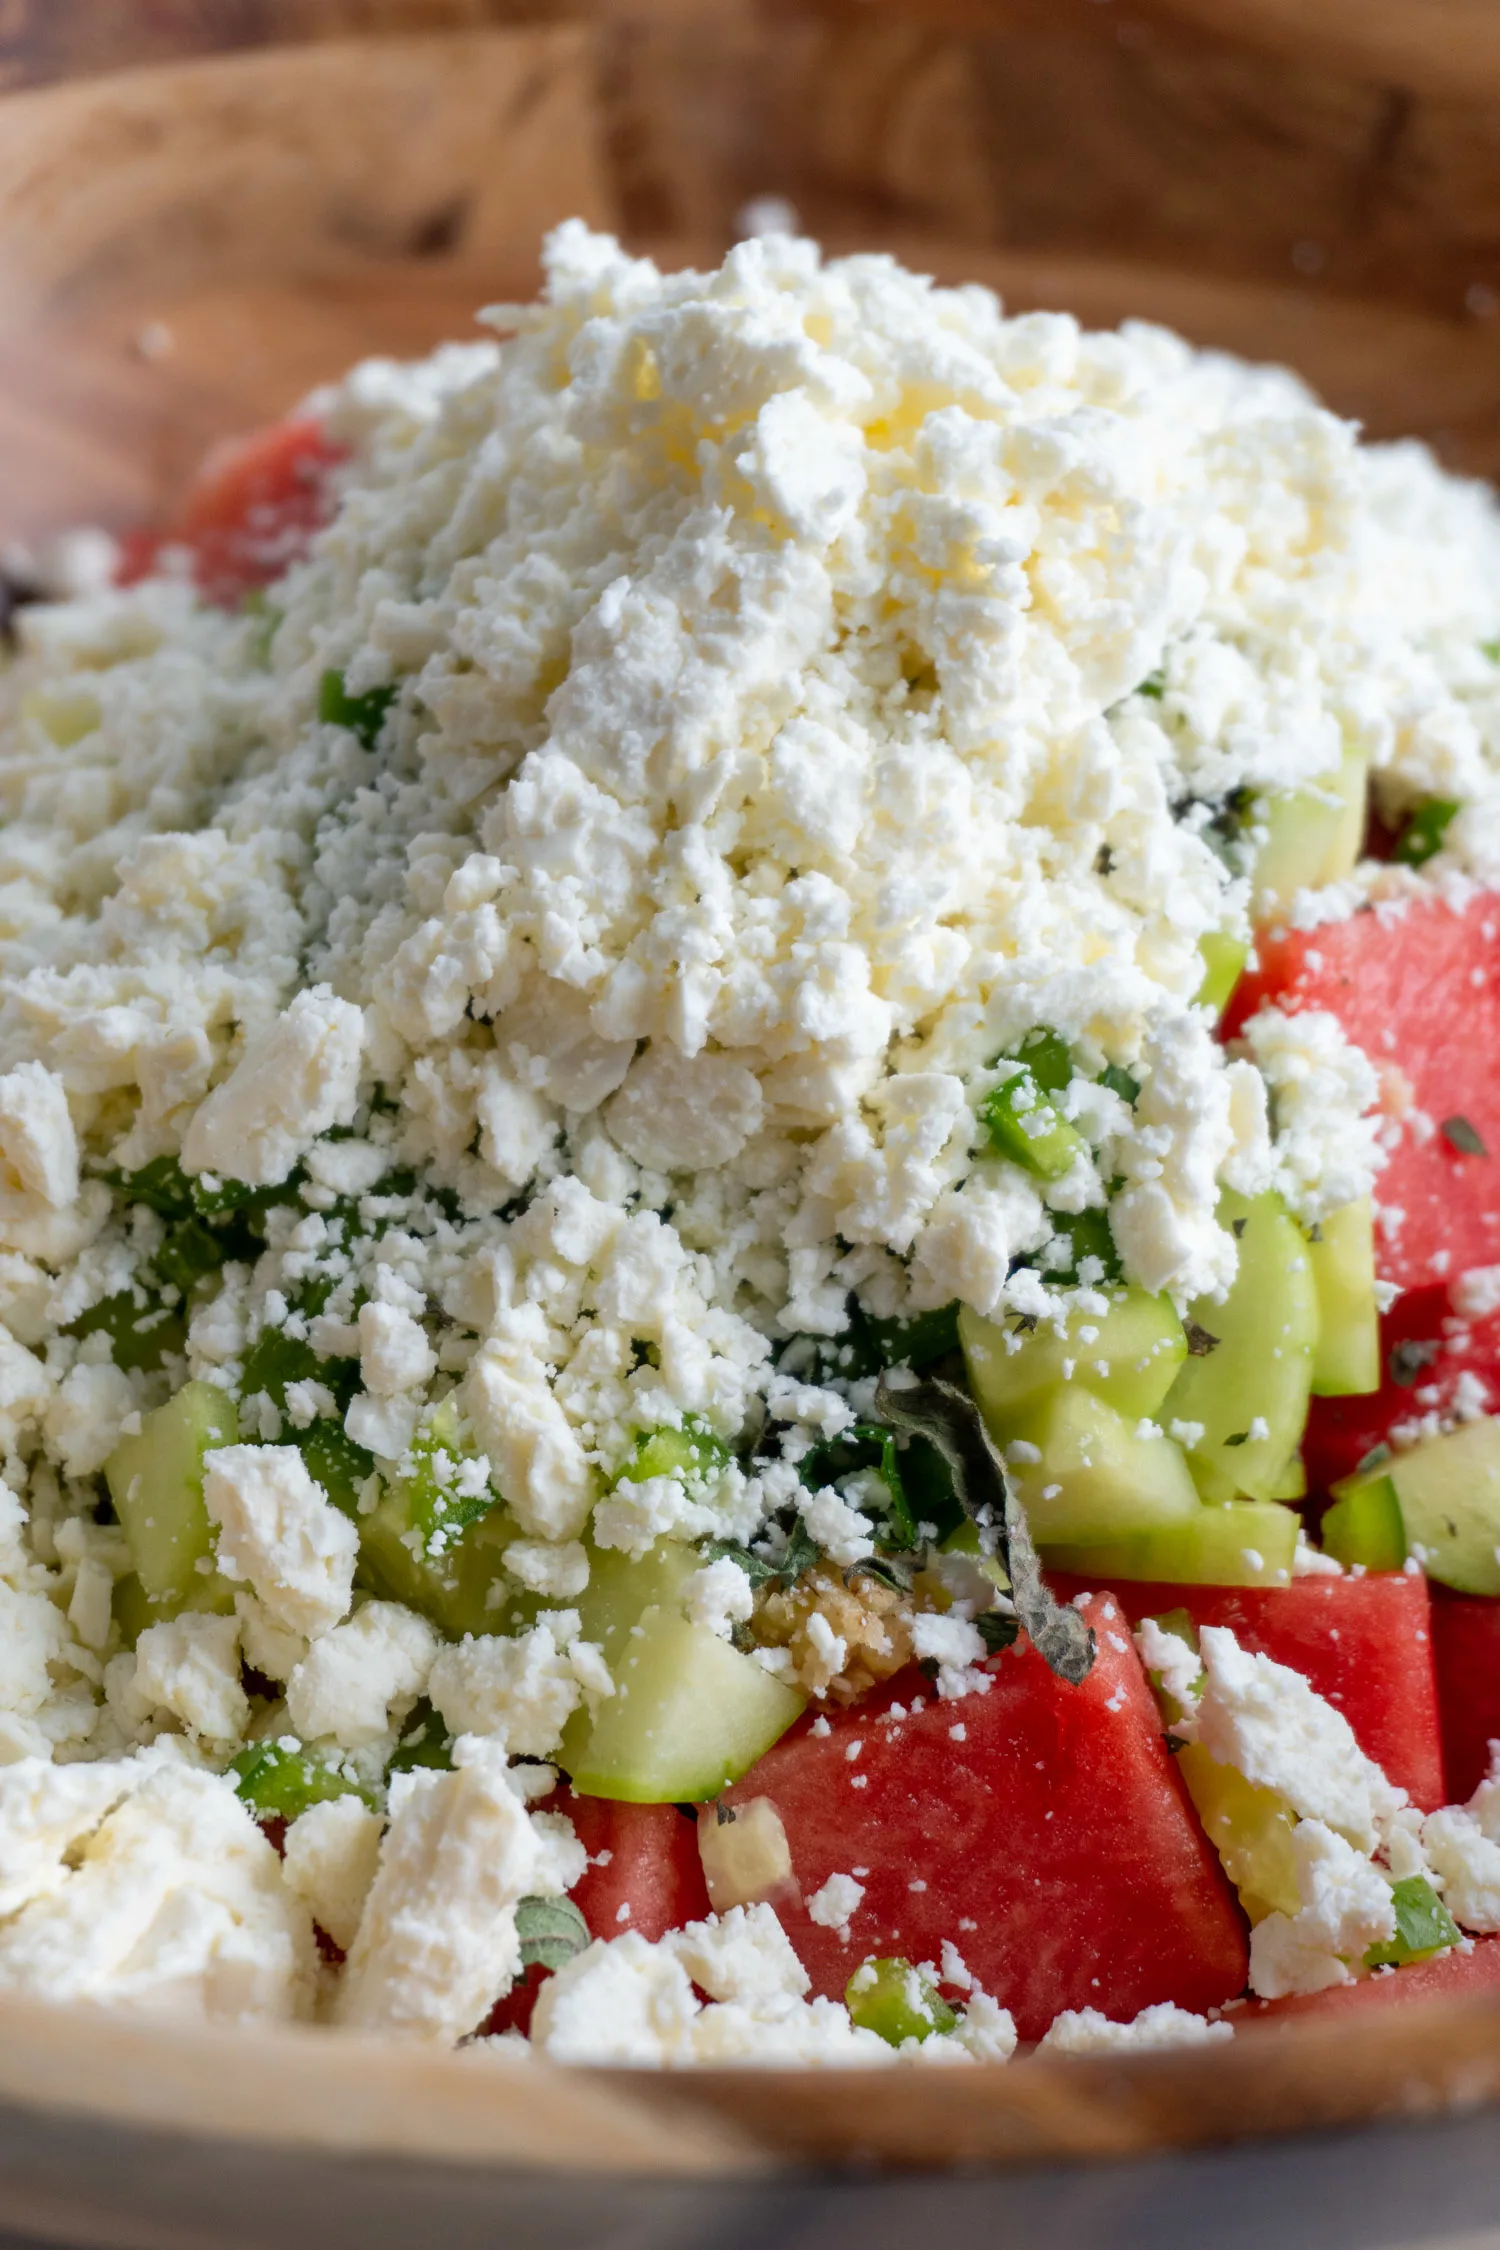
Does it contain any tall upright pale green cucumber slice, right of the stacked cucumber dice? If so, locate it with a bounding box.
[1160,1188,1318,1501]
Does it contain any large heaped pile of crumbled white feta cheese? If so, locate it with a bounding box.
[0,223,1500,2054]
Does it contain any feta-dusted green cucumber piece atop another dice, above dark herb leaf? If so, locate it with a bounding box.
[958,1287,1187,1440]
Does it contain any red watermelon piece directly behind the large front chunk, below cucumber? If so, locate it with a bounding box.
[1048,1571,1448,1811]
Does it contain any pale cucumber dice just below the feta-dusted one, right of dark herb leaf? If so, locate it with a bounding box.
[1005,1384,1201,1544]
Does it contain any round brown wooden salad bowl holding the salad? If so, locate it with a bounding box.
[0,0,1500,2250]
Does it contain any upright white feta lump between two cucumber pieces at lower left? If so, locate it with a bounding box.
[202,1445,360,1638]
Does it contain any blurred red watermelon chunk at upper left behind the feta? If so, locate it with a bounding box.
[117,414,346,610]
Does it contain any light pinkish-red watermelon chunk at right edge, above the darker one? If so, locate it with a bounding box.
[1223,891,1500,1289]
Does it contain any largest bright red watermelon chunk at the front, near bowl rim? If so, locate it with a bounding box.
[726,1600,1248,2039]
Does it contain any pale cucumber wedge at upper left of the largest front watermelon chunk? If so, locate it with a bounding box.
[573,1607,805,1805]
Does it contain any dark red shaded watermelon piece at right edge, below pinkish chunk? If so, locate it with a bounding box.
[1302,1285,1500,1492]
